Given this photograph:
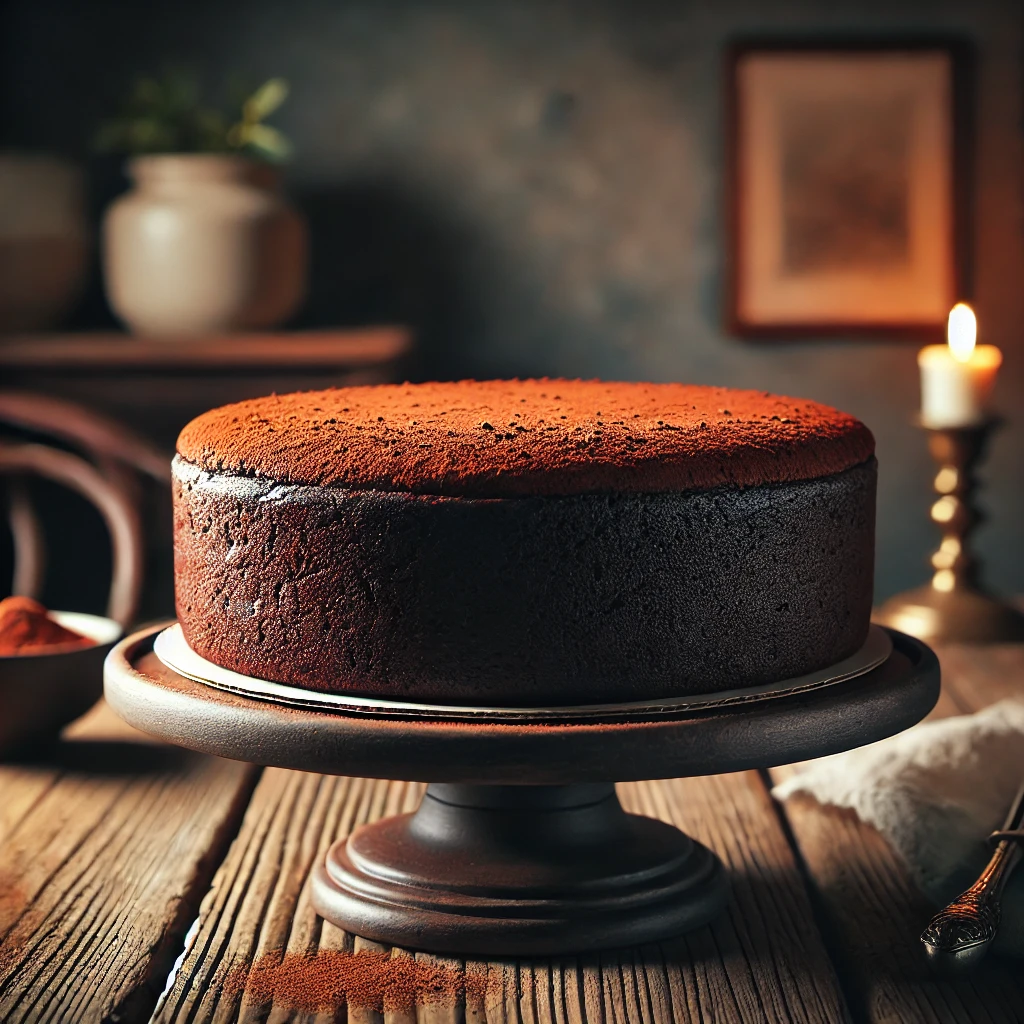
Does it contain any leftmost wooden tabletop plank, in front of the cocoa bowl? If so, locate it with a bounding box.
[0,705,257,1024]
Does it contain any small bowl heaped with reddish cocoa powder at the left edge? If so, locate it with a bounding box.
[0,597,124,757]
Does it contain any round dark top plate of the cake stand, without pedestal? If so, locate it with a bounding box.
[104,626,939,784]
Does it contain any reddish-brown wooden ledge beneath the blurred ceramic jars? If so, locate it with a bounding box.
[0,327,411,373]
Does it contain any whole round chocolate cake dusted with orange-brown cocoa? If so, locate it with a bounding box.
[174,380,876,707]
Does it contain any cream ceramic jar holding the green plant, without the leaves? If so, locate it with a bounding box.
[103,155,306,337]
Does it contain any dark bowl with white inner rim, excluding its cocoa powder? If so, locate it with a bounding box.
[0,611,124,757]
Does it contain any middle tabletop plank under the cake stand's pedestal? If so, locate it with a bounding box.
[156,769,848,1024]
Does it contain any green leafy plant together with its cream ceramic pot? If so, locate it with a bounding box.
[96,74,306,337]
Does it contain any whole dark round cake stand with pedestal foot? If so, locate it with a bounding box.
[105,627,939,956]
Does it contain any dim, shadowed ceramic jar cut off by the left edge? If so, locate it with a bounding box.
[0,153,89,333]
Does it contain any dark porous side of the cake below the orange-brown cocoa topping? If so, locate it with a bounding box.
[174,456,876,707]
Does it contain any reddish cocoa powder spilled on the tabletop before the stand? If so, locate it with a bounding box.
[224,949,487,1013]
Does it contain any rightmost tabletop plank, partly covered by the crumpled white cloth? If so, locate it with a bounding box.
[772,645,1024,1024]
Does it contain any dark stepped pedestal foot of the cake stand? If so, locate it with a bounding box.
[312,783,728,955]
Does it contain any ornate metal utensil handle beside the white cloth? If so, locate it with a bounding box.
[921,784,1024,971]
